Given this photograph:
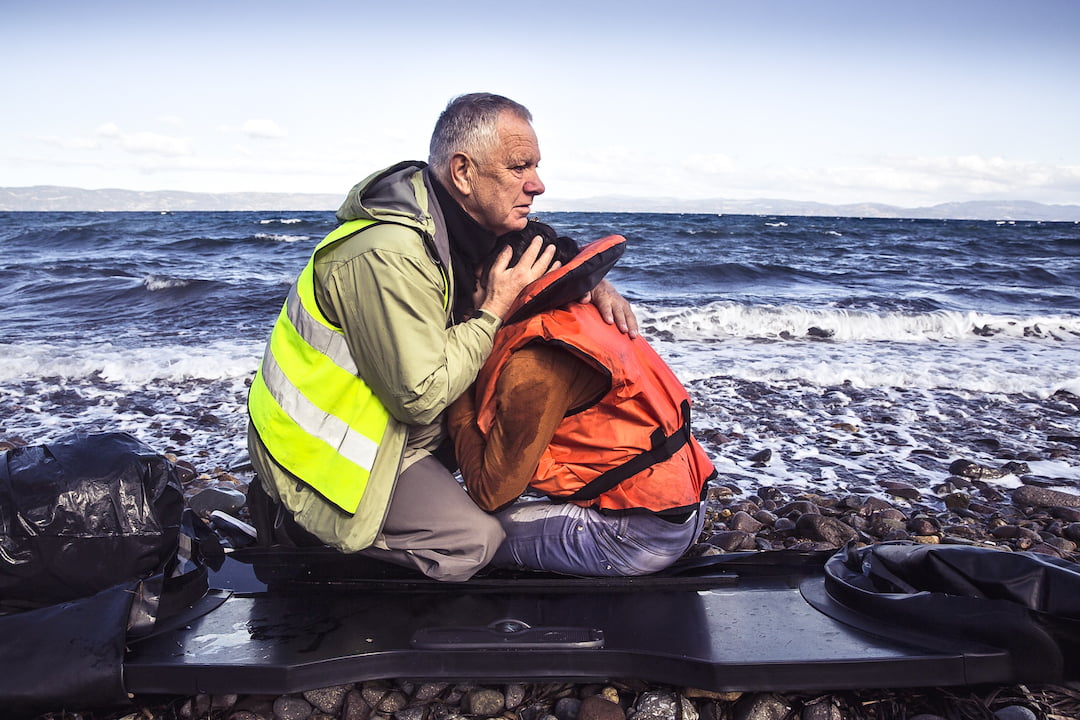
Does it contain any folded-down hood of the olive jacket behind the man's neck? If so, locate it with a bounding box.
[337,160,432,230]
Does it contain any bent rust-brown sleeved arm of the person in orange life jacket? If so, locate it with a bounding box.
[447,343,607,512]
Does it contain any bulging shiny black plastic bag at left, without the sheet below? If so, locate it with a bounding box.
[0,433,184,610]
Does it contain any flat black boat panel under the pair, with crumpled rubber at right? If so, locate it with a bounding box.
[123,544,1080,694]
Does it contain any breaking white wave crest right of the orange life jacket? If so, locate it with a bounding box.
[639,301,1080,343]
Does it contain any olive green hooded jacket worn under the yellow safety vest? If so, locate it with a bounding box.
[248,162,499,552]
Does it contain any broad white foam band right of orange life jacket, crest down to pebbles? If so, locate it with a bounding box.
[637,301,1080,397]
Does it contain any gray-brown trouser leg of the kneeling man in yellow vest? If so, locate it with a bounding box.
[360,456,504,582]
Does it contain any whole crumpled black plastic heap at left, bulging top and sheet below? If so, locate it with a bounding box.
[0,433,184,718]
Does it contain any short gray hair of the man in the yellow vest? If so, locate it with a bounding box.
[428,93,532,182]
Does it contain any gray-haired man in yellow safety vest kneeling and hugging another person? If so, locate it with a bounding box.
[248,94,636,581]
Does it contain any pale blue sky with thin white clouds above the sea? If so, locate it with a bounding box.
[0,0,1080,209]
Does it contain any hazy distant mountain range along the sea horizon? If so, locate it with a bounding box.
[0,185,1080,222]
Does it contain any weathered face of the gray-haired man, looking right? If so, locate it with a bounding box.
[462,112,544,235]
